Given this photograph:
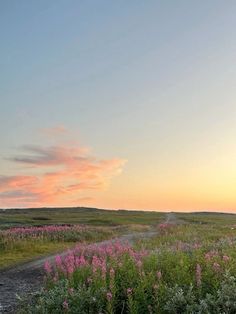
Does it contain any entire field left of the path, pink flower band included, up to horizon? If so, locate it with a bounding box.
[0,208,164,269]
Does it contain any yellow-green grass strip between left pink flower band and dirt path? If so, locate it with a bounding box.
[0,226,123,269]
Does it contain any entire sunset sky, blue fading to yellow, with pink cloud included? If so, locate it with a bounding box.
[0,0,236,212]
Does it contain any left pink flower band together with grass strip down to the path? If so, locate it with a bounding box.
[0,225,120,269]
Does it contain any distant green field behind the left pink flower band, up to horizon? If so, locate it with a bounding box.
[0,207,164,229]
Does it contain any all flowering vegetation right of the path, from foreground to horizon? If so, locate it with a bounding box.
[18,214,236,314]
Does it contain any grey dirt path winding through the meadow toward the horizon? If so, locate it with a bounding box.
[0,229,159,314]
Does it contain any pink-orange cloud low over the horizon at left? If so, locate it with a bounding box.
[0,141,125,207]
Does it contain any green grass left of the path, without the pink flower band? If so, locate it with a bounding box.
[0,207,165,268]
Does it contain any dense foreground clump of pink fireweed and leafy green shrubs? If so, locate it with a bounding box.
[26,232,236,314]
